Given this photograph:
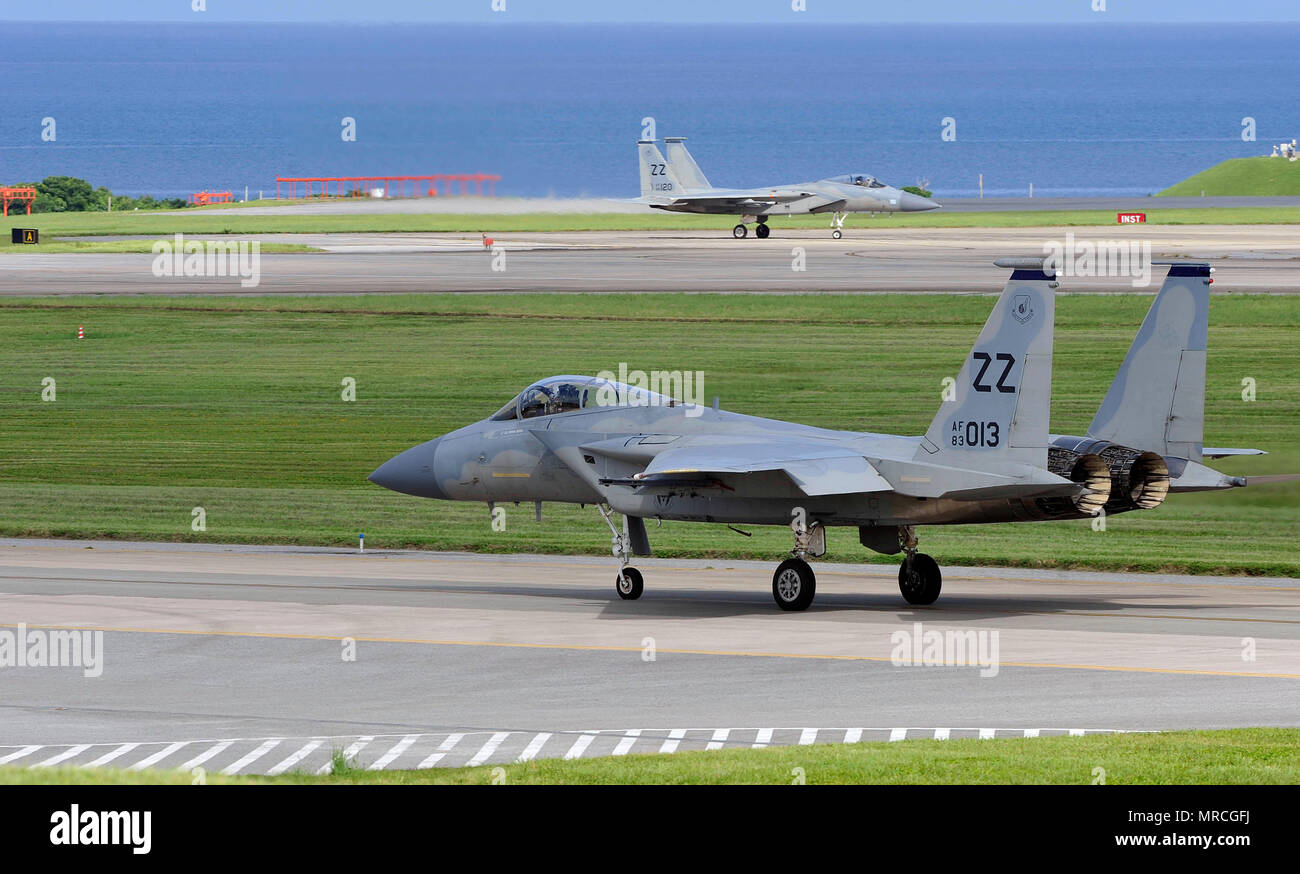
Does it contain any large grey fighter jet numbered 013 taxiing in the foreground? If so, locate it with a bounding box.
[369,258,1253,610]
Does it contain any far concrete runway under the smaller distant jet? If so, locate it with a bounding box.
[0,219,1300,297]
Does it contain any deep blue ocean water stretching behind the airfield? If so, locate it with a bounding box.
[0,22,1300,198]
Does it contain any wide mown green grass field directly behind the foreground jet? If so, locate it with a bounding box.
[0,294,1300,575]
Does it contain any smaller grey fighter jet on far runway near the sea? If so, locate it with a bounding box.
[634,137,940,239]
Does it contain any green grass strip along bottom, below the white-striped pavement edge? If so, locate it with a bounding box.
[0,728,1300,786]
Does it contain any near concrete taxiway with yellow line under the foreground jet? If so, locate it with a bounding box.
[0,540,1300,773]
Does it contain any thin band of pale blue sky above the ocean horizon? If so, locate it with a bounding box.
[0,0,1300,23]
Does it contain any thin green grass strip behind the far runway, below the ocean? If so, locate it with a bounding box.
[0,200,1300,252]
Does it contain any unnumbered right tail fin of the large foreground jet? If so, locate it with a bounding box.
[1088,263,1210,462]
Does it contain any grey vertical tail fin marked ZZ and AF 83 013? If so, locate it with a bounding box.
[917,258,1056,468]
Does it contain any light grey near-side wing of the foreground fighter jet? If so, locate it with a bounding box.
[632,442,893,496]
